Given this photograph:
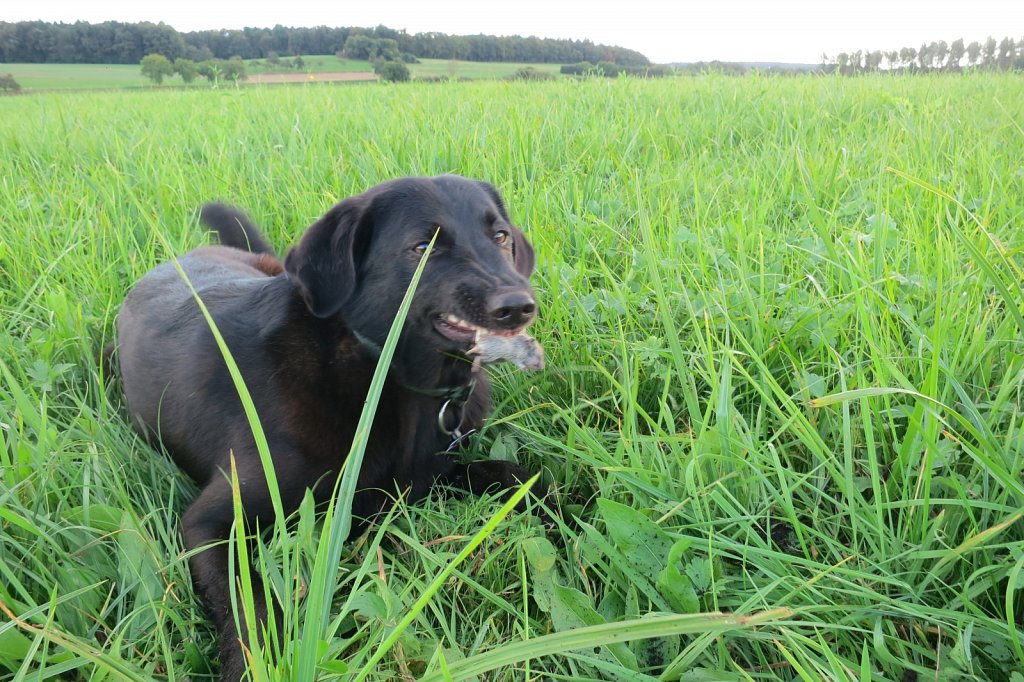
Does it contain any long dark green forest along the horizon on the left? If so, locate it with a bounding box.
[0,22,650,66]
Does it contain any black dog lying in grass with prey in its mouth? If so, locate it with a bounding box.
[111,175,537,681]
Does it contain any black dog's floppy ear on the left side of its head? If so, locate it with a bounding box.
[285,195,368,317]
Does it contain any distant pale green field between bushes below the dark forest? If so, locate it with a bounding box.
[0,55,559,90]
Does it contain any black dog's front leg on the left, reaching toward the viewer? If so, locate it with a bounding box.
[181,475,282,682]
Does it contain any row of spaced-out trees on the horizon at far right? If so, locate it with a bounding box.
[823,37,1024,76]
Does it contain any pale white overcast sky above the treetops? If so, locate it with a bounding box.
[8,0,1024,62]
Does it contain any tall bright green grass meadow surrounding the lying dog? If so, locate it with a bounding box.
[0,75,1024,682]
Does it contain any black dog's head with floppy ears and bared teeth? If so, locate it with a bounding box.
[285,175,537,388]
